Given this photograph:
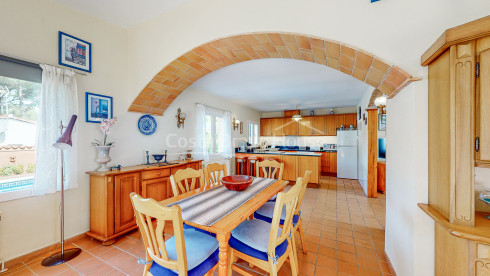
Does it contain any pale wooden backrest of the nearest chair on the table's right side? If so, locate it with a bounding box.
[268,177,303,258]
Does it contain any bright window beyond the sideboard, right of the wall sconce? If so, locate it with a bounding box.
[204,109,225,159]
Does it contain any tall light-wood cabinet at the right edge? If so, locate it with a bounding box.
[419,16,490,276]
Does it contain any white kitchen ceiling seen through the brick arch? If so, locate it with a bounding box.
[190,58,369,112]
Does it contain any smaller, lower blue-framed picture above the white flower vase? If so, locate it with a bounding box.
[85,92,113,123]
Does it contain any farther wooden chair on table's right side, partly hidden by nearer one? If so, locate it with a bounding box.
[254,170,311,254]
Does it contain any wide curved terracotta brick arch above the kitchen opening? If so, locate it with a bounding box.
[129,32,414,115]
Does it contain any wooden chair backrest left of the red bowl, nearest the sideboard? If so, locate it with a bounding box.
[170,168,204,196]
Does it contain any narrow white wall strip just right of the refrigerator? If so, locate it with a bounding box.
[357,87,374,195]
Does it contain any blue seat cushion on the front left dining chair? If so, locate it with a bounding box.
[150,229,219,275]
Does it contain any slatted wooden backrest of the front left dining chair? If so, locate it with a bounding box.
[130,193,187,275]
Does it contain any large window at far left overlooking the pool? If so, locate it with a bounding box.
[0,56,41,201]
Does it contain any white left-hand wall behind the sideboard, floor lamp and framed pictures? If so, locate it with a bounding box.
[0,0,260,260]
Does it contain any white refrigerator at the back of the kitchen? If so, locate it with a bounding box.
[337,130,357,179]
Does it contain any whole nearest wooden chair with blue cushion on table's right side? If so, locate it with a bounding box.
[228,176,302,276]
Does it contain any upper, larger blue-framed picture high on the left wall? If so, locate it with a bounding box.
[58,32,92,73]
